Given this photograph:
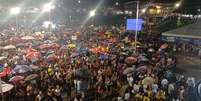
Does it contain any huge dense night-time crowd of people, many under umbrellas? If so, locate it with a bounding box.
[0,26,198,101]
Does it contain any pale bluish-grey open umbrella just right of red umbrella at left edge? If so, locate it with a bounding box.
[12,65,32,74]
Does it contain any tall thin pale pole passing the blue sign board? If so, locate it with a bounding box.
[135,1,140,53]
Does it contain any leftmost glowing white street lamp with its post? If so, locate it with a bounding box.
[10,7,21,31]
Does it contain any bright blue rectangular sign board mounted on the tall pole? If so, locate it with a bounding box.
[126,19,142,31]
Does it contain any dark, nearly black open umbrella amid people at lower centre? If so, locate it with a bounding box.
[75,68,92,78]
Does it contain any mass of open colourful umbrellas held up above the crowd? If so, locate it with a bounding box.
[0,25,181,101]
